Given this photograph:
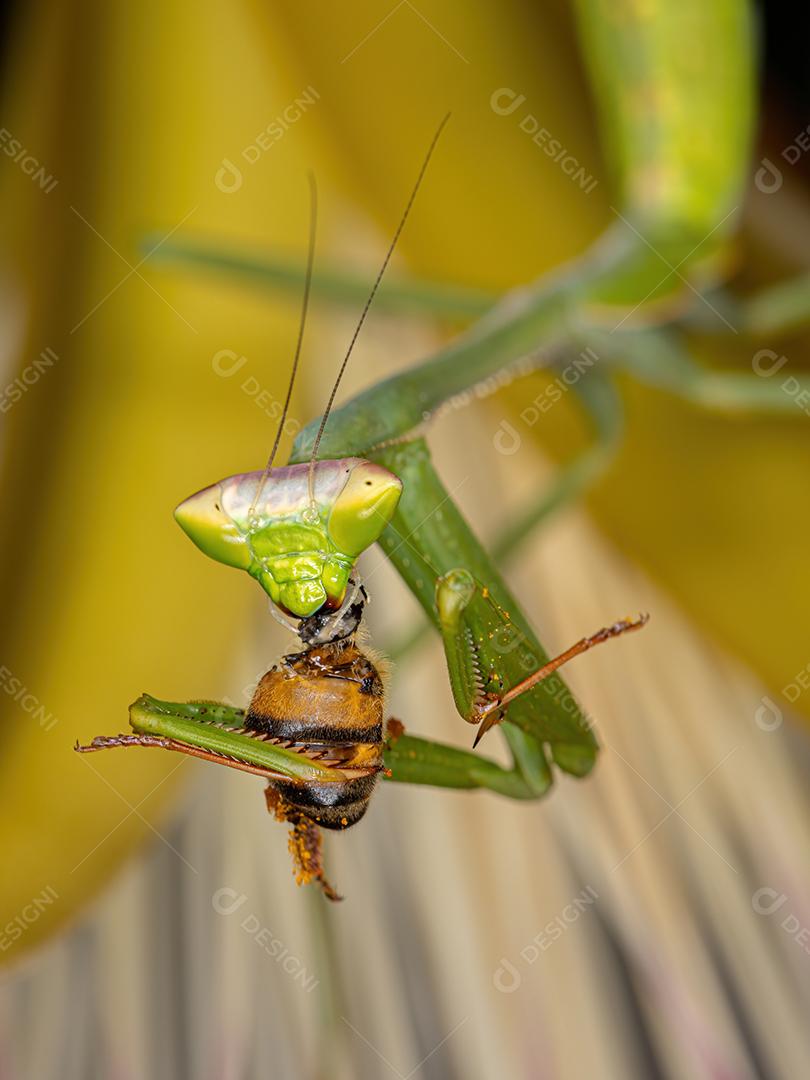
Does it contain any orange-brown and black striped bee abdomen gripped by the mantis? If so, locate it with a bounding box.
[245,638,383,829]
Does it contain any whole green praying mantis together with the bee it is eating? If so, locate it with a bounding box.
[74,0,784,899]
